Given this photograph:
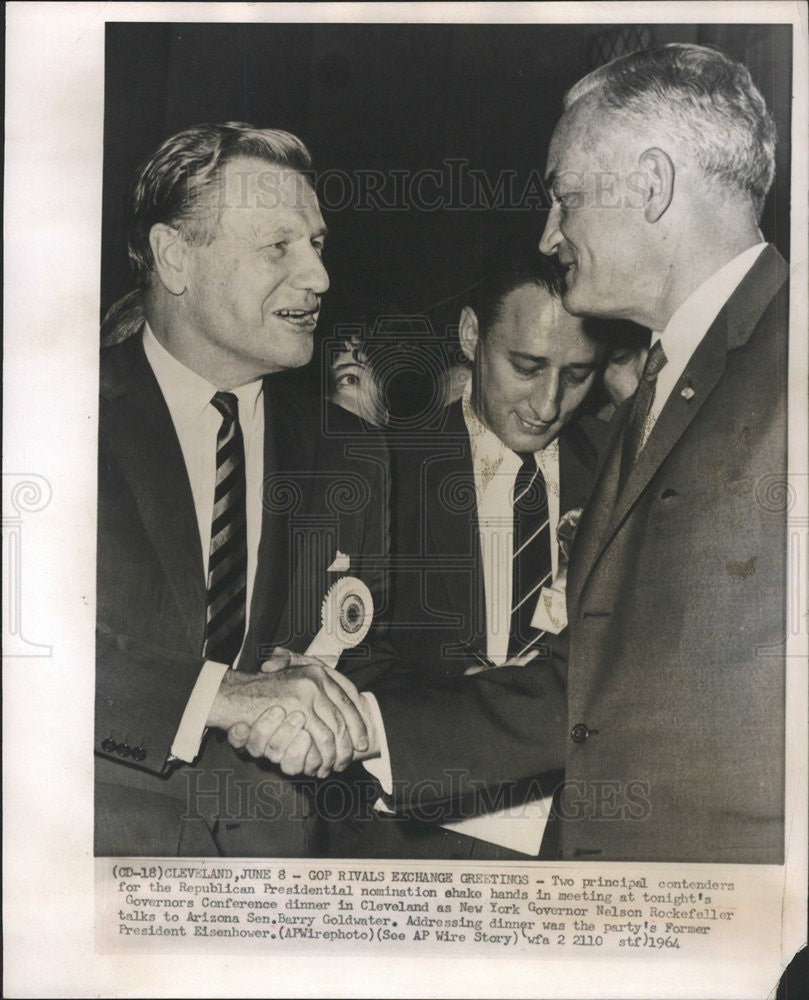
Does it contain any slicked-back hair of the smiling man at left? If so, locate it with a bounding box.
[126,122,312,288]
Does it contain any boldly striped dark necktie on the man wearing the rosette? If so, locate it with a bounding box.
[203,392,247,664]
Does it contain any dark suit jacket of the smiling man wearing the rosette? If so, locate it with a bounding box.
[95,336,388,854]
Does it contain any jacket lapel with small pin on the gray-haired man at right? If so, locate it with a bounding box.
[569,246,788,607]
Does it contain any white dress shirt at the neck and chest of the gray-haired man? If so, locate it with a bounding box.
[641,243,767,447]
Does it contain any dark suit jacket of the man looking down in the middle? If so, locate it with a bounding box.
[331,401,611,858]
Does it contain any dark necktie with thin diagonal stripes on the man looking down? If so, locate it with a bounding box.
[508,452,551,659]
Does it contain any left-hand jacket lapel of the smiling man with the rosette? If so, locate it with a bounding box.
[101,335,206,654]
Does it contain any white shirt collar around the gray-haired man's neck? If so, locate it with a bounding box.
[652,243,767,372]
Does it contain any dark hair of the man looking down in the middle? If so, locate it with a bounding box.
[474,242,565,336]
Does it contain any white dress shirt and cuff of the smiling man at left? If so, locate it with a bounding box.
[143,323,264,762]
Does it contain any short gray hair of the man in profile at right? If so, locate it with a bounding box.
[564,43,775,214]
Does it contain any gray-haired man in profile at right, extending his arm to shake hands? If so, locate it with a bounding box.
[237,44,788,864]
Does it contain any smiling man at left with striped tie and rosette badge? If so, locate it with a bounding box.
[95,123,387,854]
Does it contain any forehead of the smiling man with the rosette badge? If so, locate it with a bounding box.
[218,157,323,226]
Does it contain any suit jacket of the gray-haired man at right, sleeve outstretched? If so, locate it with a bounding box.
[379,247,788,863]
